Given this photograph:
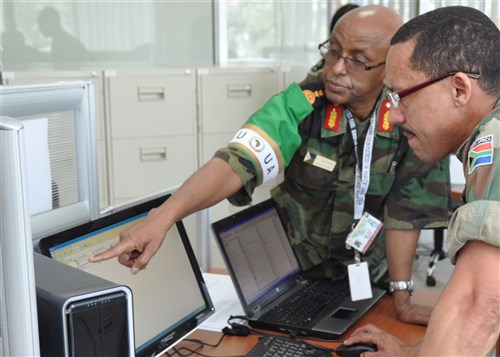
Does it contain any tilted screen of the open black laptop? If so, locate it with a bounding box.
[212,200,300,305]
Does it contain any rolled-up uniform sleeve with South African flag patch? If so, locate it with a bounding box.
[447,101,500,263]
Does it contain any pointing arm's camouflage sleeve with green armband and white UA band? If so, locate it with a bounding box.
[215,83,315,205]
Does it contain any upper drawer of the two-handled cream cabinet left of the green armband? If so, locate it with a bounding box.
[106,72,196,138]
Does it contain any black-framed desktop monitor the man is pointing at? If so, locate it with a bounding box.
[39,194,215,357]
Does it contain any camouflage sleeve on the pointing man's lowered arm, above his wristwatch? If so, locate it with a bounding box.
[384,149,451,229]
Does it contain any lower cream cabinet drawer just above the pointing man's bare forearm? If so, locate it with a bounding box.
[112,135,196,202]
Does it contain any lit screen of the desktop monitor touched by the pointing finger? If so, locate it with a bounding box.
[49,213,211,355]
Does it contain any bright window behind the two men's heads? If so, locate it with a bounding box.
[218,0,500,65]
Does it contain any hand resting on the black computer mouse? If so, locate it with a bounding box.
[344,324,417,357]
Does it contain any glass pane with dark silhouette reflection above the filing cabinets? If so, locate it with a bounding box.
[0,0,214,70]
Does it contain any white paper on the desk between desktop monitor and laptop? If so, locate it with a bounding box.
[199,273,244,332]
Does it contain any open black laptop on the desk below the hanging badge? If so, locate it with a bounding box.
[212,199,385,339]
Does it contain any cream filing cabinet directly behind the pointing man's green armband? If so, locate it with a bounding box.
[198,67,282,267]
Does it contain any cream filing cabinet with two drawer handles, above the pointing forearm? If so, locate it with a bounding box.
[104,69,198,205]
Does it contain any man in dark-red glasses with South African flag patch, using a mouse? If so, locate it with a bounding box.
[346,6,500,356]
